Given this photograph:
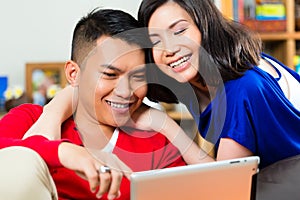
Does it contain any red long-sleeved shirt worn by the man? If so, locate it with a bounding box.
[0,104,185,200]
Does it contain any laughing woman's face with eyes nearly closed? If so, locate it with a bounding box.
[148,1,201,82]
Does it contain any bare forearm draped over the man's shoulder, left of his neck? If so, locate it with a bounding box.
[23,86,73,140]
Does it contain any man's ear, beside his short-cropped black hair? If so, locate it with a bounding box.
[65,60,80,87]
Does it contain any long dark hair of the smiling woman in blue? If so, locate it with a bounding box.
[138,0,262,88]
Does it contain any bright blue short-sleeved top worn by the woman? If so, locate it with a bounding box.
[190,54,300,168]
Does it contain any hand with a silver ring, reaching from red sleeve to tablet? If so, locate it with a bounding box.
[58,142,132,199]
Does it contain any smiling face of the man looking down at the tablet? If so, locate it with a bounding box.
[78,36,147,127]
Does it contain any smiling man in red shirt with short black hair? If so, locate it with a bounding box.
[0,9,185,200]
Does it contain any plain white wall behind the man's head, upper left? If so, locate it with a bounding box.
[0,0,141,88]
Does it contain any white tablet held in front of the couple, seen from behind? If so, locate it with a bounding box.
[130,156,259,200]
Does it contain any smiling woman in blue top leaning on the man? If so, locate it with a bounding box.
[27,0,300,169]
